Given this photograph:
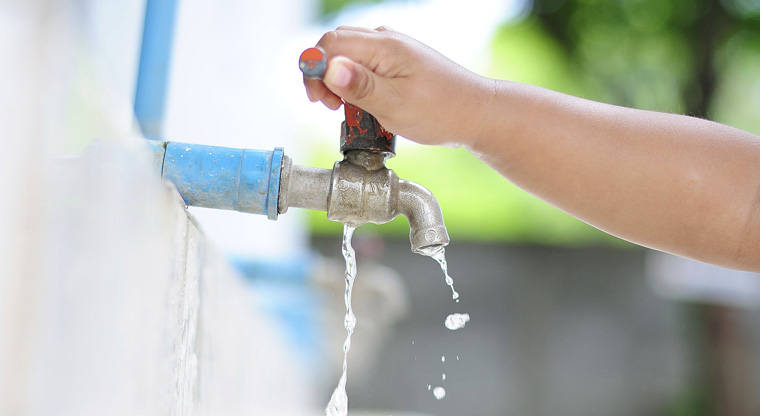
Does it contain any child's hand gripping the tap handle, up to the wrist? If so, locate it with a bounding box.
[304,27,494,146]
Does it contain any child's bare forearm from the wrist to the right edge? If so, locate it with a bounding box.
[468,82,760,270]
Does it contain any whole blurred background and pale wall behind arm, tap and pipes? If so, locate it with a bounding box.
[0,0,760,416]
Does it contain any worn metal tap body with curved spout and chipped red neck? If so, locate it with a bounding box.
[278,103,449,255]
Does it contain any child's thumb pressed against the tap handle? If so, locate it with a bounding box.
[324,56,387,113]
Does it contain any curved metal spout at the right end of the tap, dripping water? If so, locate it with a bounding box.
[397,179,449,255]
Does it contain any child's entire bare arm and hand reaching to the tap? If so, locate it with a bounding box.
[304,27,760,272]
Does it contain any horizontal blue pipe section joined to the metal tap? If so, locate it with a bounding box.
[147,140,283,220]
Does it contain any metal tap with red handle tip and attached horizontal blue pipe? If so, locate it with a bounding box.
[147,48,449,255]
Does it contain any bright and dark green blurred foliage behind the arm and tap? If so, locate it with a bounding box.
[309,0,760,245]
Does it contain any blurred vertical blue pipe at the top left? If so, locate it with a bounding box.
[135,0,177,140]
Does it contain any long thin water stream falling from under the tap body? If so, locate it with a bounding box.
[325,224,356,416]
